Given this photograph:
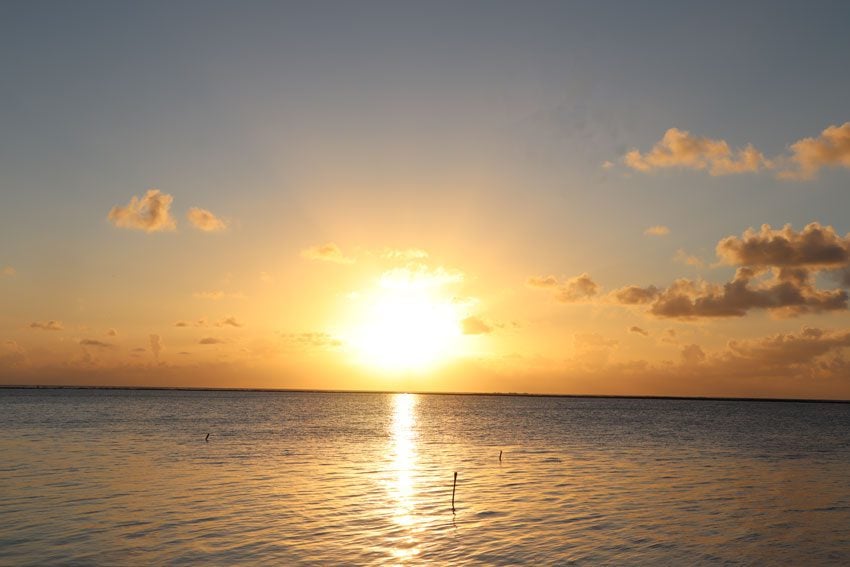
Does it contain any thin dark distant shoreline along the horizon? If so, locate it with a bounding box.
[0,384,850,404]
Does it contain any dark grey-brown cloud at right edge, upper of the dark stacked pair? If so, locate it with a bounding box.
[717,222,850,268]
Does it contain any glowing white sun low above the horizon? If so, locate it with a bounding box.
[346,270,463,372]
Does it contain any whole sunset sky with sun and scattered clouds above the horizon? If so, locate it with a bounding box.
[0,1,850,399]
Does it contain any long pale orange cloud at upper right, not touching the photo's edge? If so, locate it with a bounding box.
[623,128,773,175]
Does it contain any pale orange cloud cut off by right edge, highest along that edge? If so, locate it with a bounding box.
[779,122,850,179]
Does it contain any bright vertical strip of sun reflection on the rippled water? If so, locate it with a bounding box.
[389,394,420,559]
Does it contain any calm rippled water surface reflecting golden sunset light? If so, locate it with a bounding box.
[0,390,850,565]
